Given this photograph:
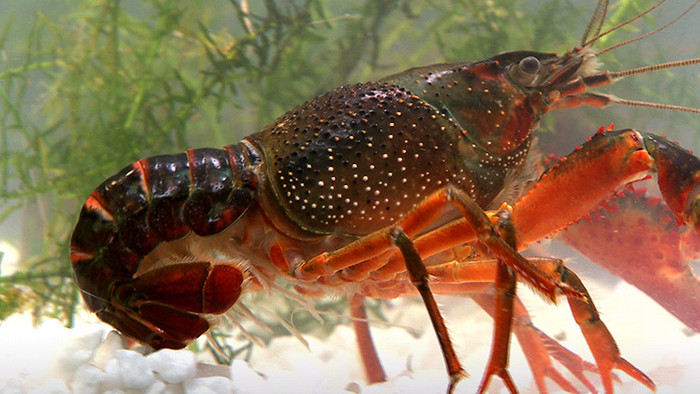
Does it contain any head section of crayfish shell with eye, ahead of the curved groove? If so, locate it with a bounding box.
[381,51,556,157]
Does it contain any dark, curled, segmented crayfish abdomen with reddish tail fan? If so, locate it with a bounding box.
[71,144,257,348]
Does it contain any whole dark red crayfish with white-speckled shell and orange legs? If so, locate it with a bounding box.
[71,2,700,392]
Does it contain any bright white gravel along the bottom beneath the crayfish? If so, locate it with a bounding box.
[0,272,700,394]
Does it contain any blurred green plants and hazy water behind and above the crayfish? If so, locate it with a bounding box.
[0,0,700,344]
